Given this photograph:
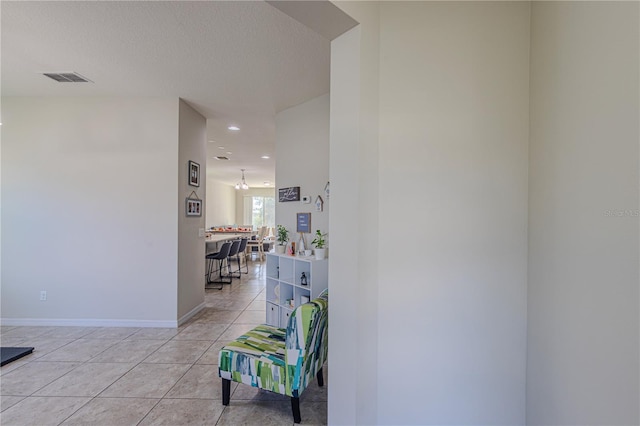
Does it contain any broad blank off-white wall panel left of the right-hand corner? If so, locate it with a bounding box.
[378,2,529,425]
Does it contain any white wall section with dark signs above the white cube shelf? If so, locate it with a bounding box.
[275,94,331,247]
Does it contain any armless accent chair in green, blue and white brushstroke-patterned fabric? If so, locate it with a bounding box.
[218,290,329,423]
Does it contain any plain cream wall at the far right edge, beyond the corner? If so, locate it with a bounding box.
[527,2,640,425]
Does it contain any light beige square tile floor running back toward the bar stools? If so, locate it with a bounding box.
[0,261,327,426]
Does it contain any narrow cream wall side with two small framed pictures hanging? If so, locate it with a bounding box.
[177,100,207,323]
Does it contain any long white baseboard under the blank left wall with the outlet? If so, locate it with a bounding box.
[0,318,178,328]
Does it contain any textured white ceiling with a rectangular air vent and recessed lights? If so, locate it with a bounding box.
[0,0,330,187]
